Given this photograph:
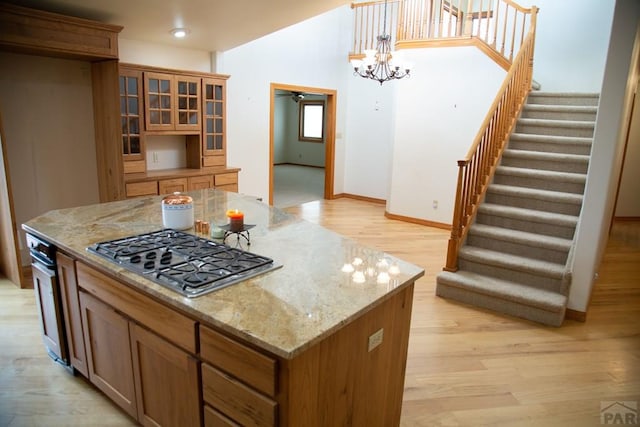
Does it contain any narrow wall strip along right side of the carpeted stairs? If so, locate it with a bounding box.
[568,0,640,312]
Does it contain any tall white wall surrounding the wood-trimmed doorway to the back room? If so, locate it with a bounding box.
[218,6,352,200]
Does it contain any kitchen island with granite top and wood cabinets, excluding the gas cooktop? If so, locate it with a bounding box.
[23,189,424,426]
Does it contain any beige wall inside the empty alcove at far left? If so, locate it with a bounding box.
[0,52,99,264]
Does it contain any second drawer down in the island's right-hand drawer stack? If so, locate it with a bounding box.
[202,363,278,426]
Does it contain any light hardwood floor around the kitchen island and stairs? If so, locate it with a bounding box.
[0,199,640,427]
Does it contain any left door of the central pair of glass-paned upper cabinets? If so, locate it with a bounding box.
[144,72,175,131]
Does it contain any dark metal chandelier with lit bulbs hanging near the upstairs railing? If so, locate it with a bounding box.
[351,0,411,86]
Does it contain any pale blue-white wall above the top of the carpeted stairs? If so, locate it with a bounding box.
[516,0,615,92]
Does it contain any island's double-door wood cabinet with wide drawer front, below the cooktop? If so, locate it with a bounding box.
[78,263,202,426]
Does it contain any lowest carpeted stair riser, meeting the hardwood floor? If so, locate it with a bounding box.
[436,283,565,326]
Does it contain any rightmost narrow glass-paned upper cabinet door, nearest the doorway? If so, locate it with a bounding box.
[202,79,227,160]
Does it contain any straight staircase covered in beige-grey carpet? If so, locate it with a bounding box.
[436,92,599,326]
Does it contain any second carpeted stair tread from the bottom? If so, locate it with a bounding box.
[458,245,564,279]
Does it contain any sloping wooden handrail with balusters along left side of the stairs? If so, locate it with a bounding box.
[444,6,538,271]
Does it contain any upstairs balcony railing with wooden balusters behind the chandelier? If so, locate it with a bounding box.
[349,0,533,70]
